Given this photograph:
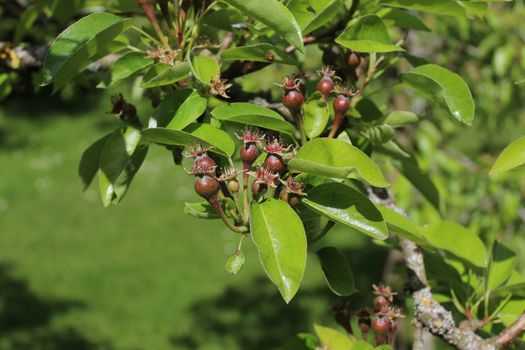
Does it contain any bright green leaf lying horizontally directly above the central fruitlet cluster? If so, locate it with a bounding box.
[211,102,295,137]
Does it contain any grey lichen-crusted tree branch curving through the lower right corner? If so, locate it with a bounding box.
[369,188,525,350]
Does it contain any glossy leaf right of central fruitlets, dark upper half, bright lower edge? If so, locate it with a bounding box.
[302,182,388,239]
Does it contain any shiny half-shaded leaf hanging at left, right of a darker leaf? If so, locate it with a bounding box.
[99,127,148,207]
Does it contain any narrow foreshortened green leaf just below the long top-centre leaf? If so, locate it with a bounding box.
[221,43,297,65]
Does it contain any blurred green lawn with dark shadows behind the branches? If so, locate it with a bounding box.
[0,93,384,350]
